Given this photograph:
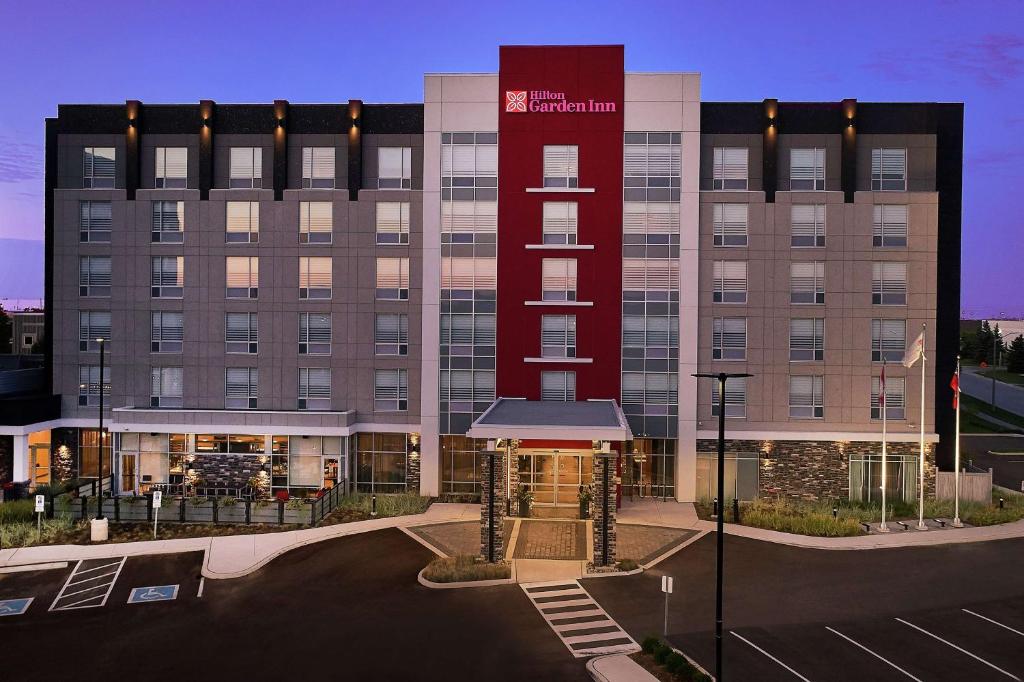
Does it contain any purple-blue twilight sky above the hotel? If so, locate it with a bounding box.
[0,0,1024,316]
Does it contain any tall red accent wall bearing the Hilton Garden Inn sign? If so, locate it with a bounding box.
[496,45,625,400]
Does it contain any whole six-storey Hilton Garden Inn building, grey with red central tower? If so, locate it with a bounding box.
[0,46,963,507]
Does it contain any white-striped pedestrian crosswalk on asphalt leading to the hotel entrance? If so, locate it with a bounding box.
[520,581,640,658]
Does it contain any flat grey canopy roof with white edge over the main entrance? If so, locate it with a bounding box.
[466,398,633,440]
